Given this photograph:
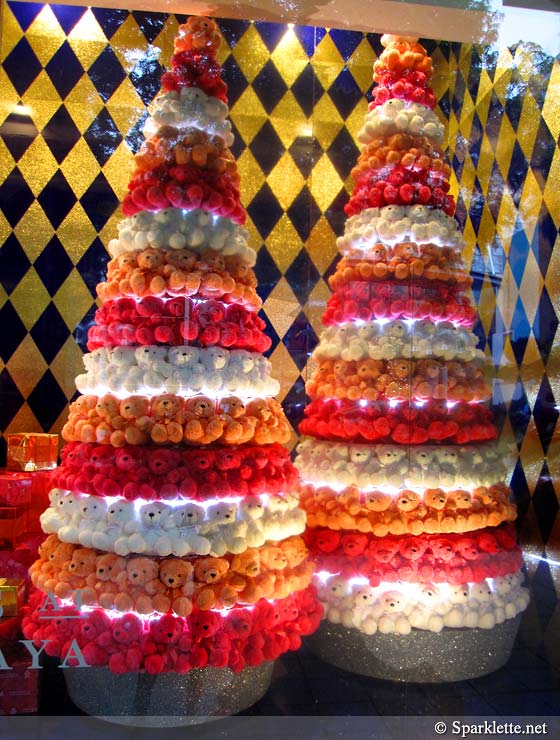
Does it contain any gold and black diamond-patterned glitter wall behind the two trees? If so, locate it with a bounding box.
[0,2,560,544]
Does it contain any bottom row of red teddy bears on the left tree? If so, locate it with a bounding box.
[23,589,323,674]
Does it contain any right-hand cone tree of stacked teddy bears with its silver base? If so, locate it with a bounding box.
[296,35,528,680]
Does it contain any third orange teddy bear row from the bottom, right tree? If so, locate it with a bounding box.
[329,247,472,290]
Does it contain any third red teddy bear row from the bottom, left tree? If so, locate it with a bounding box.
[87,296,272,352]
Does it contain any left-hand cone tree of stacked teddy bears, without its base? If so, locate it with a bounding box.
[23,17,321,673]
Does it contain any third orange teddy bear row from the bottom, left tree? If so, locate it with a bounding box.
[97,247,262,311]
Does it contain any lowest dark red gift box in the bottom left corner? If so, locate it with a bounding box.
[0,650,39,715]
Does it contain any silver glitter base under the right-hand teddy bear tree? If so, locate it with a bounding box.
[305,615,521,683]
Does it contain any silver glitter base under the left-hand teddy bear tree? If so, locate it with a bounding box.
[64,662,274,727]
